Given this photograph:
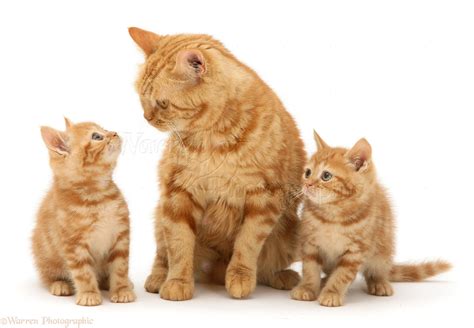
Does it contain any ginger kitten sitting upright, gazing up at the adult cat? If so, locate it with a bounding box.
[33,119,135,306]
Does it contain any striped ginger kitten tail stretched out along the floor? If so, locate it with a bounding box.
[390,261,452,282]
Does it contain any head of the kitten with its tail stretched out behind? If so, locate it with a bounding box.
[303,131,375,205]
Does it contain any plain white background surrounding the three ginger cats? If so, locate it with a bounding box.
[0,0,474,327]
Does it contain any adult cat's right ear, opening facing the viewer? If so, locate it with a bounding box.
[174,49,206,80]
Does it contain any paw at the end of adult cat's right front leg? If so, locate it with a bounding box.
[225,265,257,298]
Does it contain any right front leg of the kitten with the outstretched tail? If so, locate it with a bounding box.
[318,251,363,307]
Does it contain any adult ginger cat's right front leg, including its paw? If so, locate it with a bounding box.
[225,188,282,298]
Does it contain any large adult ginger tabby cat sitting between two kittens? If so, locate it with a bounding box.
[129,28,305,300]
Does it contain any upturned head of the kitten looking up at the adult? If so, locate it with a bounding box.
[41,118,122,177]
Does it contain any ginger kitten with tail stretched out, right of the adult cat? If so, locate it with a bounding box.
[291,132,451,307]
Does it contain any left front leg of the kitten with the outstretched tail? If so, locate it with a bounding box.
[291,241,322,301]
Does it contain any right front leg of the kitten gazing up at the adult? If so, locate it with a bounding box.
[108,228,136,303]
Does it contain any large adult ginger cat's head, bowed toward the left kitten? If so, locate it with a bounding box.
[129,27,252,131]
